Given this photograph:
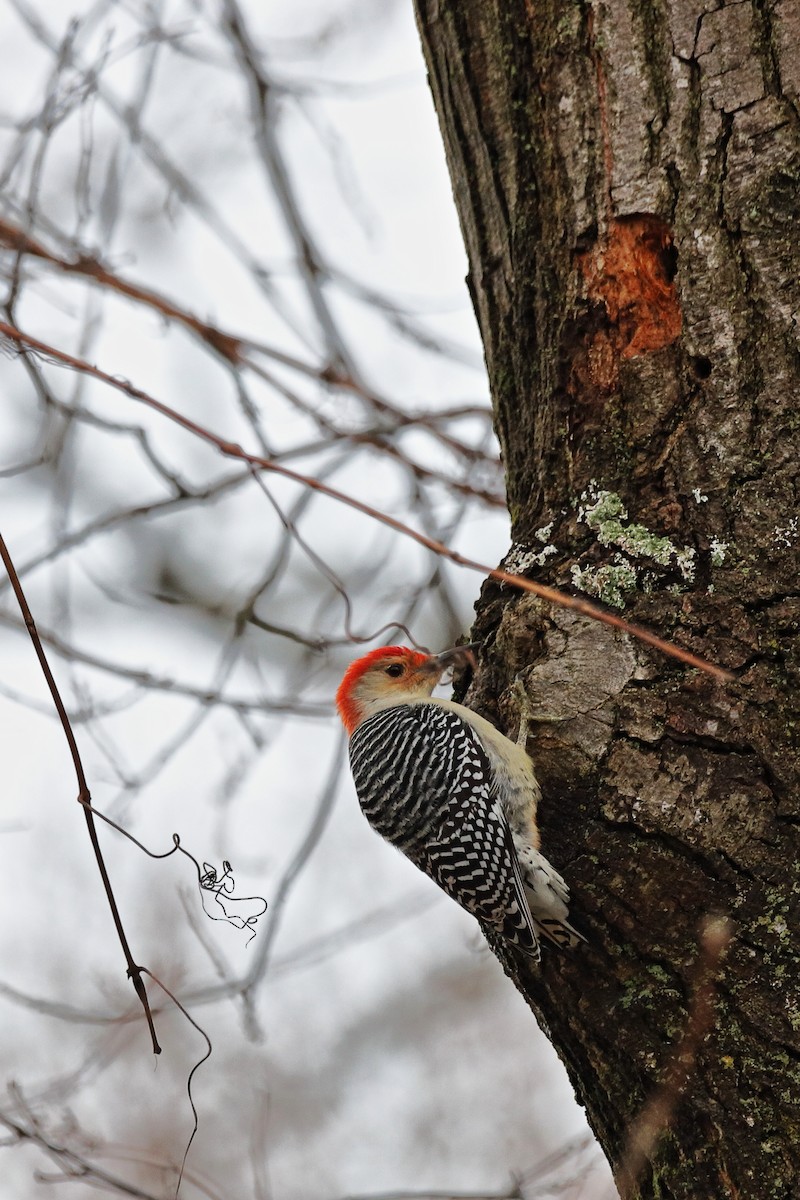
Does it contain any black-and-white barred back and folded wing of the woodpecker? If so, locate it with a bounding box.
[350,702,544,959]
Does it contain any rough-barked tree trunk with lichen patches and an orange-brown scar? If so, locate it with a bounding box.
[416,0,800,1200]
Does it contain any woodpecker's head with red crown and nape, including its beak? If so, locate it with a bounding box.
[336,646,475,733]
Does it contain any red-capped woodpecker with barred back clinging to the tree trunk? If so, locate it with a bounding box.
[336,646,585,961]
